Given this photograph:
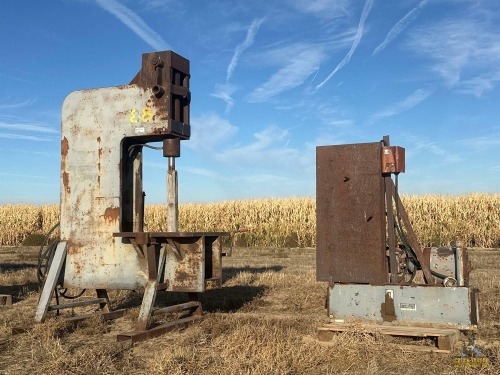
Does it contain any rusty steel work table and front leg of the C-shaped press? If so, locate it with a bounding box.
[113,232,229,342]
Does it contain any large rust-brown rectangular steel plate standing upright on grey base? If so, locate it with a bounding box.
[316,142,388,284]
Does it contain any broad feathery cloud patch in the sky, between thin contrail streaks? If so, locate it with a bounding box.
[247,46,324,103]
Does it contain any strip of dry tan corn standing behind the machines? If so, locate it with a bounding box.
[0,194,500,247]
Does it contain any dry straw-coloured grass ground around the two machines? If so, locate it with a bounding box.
[0,247,500,375]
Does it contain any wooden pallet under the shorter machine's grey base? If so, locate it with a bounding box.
[318,323,460,353]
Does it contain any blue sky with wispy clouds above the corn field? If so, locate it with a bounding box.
[0,0,500,203]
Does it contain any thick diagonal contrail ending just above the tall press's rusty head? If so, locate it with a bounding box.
[95,0,171,51]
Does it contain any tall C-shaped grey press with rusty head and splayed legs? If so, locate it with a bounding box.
[35,51,227,340]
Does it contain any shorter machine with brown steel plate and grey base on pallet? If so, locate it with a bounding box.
[316,136,479,329]
